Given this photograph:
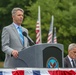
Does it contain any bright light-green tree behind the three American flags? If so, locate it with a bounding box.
[24,0,76,55]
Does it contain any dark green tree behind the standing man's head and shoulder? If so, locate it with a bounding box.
[0,0,36,61]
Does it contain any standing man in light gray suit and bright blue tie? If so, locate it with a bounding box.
[2,8,29,68]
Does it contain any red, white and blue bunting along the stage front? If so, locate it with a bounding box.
[0,70,76,75]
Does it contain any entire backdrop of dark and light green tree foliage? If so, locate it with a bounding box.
[0,0,76,60]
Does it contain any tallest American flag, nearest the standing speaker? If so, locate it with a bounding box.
[36,6,42,44]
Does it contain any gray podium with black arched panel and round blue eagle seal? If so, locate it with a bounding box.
[12,43,64,68]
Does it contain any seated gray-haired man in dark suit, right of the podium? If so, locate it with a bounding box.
[64,43,76,68]
